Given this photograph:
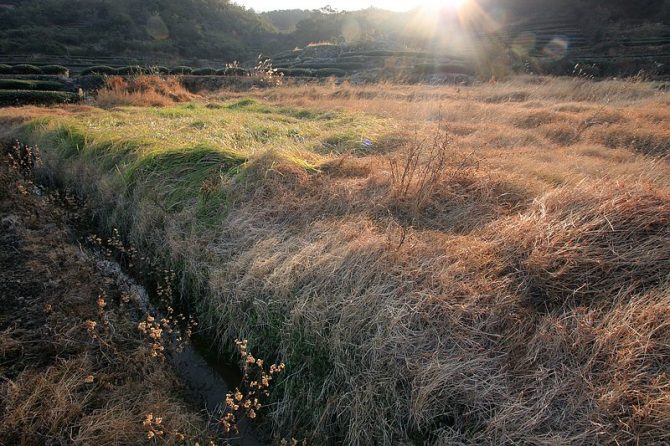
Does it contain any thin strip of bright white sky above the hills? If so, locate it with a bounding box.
[233,0,426,12]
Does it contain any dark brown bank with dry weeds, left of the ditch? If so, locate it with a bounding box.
[0,147,215,445]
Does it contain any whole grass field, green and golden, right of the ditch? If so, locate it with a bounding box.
[0,78,670,445]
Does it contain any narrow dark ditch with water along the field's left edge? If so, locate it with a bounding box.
[0,143,270,446]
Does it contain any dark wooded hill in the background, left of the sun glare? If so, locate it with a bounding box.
[0,0,280,63]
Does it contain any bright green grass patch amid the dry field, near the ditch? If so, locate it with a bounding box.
[14,99,390,223]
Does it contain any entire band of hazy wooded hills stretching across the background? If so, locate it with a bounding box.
[0,0,670,76]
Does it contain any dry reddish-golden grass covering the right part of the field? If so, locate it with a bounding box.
[202,76,670,444]
